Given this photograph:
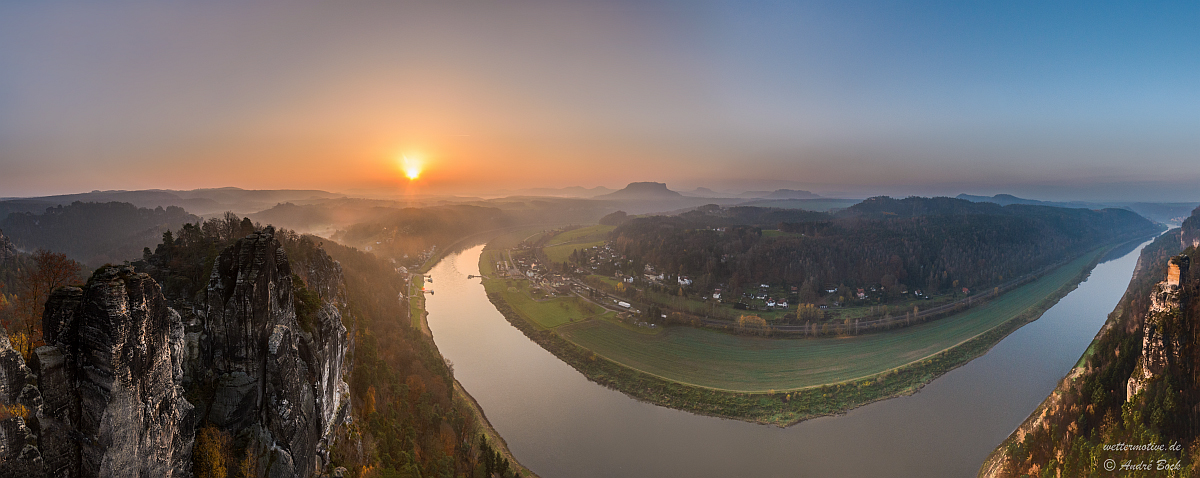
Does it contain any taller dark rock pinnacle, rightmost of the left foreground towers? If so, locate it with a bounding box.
[199,227,348,477]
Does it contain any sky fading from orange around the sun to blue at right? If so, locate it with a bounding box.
[0,0,1200,201]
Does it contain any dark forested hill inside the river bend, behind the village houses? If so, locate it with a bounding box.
[610,197,1159,299]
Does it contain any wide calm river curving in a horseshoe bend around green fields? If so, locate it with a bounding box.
[426,238,1148,478]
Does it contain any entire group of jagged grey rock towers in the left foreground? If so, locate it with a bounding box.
[0,227,349,477]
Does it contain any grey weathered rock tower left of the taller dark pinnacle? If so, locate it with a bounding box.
[34,265,194,477]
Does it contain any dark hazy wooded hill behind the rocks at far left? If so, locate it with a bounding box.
[0,202,199,265]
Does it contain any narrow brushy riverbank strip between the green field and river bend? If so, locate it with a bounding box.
[480,238,1103,426]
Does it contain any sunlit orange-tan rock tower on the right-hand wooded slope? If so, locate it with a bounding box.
[1126,256,1190,401]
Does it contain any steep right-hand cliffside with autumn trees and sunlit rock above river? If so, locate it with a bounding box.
[979,209,1200,477]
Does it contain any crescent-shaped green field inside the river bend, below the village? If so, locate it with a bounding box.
[560,246,1099,392]
